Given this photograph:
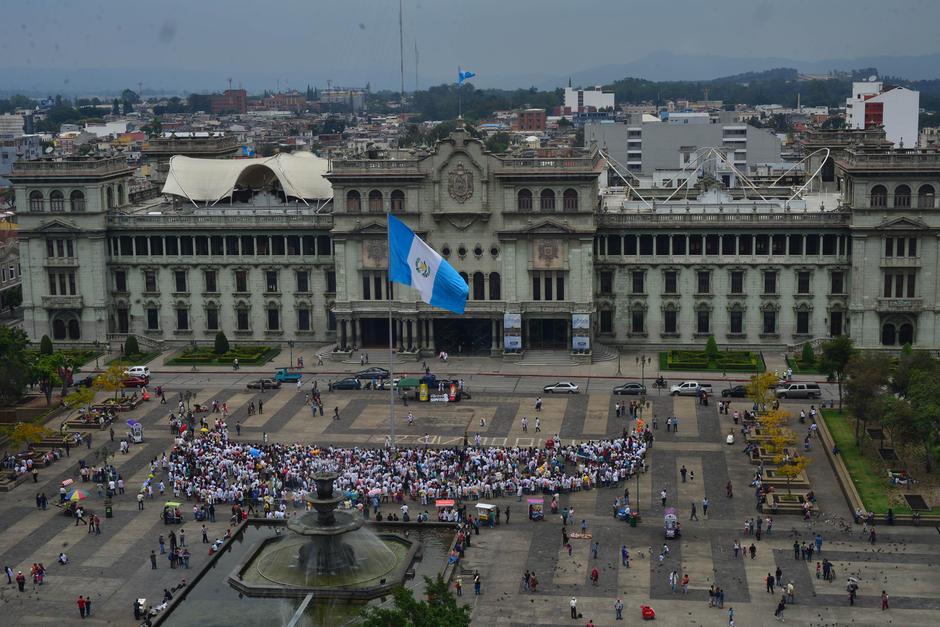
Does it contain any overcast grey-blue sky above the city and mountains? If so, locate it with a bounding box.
[0,0,940,88]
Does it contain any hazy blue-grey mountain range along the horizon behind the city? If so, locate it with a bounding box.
[0,51,940,96]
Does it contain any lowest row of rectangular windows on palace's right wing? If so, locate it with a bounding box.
[598,309,842,335]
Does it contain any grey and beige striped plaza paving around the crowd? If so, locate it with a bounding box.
[0,359,940,625]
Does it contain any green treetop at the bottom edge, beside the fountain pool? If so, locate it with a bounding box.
[362,575,470,627]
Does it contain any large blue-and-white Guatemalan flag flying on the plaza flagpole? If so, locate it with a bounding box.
[388,215,469,314]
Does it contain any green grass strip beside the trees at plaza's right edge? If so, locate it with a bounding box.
[822,409,940,515]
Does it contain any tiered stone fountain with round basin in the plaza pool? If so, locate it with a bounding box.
[229,472,419,600]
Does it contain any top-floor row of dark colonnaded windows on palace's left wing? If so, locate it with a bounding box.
[108,235,333,257]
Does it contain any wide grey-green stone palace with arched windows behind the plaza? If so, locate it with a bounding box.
[10,129,940,361]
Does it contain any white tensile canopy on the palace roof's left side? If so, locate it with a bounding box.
[162,152,333,203]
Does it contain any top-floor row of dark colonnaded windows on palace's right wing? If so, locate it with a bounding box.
[594,233,852,257]
